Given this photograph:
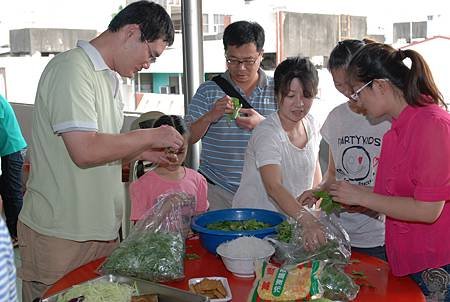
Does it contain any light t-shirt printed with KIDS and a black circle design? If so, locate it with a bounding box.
[320,103,391,248]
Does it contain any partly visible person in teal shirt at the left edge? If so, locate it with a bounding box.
[0,95,27,247]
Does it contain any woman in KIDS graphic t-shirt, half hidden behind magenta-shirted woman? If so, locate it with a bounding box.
[299,40,391,260]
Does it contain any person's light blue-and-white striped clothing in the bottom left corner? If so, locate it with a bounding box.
[0,214,17,302]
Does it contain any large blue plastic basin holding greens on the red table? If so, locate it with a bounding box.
[191,208,286,254]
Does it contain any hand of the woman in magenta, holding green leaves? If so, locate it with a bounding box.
[329,181,368,206]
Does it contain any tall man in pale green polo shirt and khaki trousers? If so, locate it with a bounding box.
[18,1,184,301]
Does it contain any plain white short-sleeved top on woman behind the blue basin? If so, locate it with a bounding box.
[233,112,320,212]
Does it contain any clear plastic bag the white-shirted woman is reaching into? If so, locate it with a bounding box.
[267,209,351,265]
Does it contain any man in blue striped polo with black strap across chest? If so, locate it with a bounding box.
[186,21,276,210]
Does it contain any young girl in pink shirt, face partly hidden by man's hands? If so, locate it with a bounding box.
[129,115,209,221]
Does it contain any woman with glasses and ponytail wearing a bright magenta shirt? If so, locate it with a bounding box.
[330,43,450,301]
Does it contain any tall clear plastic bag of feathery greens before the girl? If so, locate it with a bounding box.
[101,192,195,282]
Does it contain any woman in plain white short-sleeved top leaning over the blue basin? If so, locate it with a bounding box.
[233,57,322,218]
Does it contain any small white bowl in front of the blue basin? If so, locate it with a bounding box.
[217,238,275,278]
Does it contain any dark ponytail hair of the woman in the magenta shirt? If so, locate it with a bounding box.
[347,43,447,108]
